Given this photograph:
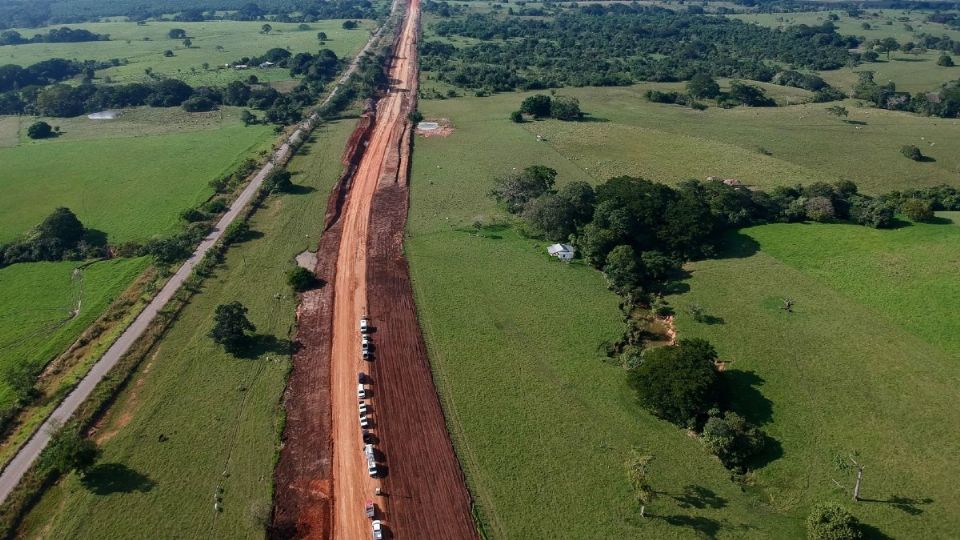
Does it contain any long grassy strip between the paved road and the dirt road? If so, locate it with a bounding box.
[17,117,353,539]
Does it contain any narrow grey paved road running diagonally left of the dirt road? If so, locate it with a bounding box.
[0,20,394,503]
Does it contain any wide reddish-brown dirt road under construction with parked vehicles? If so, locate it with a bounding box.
[273,0,478,539]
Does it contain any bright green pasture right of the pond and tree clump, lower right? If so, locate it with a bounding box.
[671,219,960,538]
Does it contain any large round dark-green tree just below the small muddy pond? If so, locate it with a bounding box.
[629,338,719,426]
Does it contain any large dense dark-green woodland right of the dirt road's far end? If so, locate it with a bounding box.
[421,4,858,91]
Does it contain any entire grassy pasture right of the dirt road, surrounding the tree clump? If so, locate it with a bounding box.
[406,78,960,538]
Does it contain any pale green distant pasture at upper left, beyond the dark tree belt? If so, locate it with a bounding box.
[0,20,375,86]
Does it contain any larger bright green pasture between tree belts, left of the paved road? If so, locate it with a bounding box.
[0,109,272,243]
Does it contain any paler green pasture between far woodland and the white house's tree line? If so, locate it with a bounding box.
[423,82,960,193]
